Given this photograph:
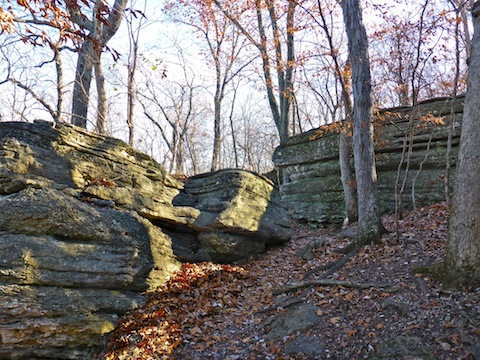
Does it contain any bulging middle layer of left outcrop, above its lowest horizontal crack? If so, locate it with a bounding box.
[0,189,178,291]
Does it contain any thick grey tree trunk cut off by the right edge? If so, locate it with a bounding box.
[445,1,480,288]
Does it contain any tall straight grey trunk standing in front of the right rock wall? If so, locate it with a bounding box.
[341,0,383,244]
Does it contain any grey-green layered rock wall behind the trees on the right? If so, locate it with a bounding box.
[273,97,464,226]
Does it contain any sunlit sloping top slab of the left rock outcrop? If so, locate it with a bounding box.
[0,122,183,211]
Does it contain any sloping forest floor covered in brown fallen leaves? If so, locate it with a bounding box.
[102,204,480,360]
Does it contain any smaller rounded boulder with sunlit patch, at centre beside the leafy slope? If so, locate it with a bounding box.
[170,169,291,262]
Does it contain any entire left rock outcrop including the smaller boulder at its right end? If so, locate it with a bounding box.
[0,122,290,359]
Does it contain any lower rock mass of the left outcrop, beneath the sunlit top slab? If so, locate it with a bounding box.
[0,188,178,359]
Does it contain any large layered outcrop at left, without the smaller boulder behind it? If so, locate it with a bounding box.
[0,123,180,359]
